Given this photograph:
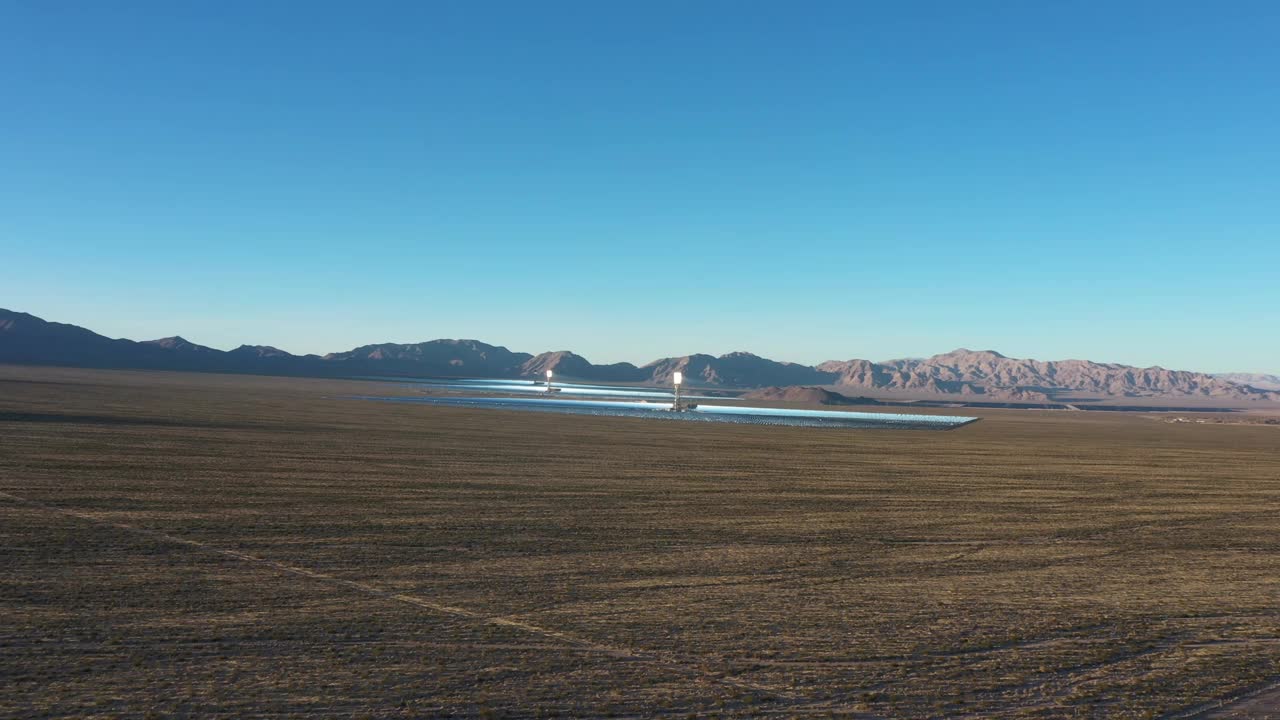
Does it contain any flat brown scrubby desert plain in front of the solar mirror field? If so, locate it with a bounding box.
[0,366,1280,717]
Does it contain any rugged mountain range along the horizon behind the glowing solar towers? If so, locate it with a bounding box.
[0,309,1280,402]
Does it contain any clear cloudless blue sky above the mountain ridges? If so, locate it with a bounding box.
[0,0,1280,372]
